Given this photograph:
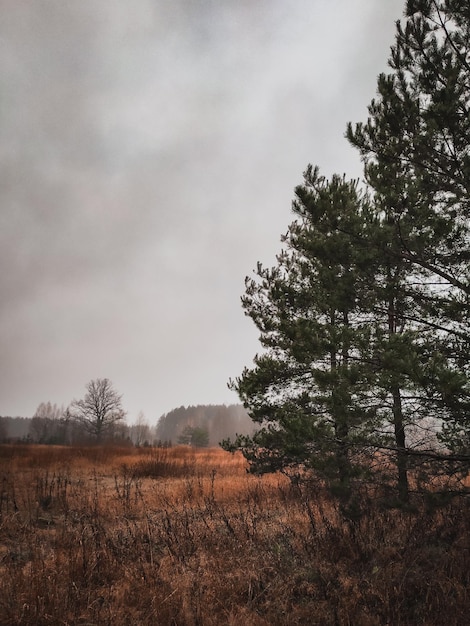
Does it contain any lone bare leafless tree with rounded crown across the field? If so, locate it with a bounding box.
[70,378,126,441]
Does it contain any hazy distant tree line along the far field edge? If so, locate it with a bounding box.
[0,378,254,447]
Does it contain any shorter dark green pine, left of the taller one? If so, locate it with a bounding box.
[223,167,377,499]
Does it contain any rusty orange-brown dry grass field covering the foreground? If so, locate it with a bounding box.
[0,446,470,626]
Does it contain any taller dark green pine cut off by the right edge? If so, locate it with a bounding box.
[347,0,470,460]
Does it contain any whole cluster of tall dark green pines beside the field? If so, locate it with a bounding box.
[224,0,470,502]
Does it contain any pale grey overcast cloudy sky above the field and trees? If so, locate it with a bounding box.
[0,0,404,423]
